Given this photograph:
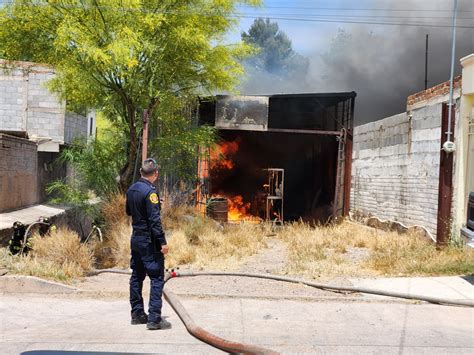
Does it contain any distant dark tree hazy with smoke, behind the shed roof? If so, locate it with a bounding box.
[241,18,309,91]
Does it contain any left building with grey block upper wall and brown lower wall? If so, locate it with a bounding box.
[0,60,96,212]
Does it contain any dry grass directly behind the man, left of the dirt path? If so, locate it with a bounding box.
[93,196,265,269]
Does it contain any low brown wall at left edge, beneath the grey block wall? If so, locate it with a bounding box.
[0,134,38,212]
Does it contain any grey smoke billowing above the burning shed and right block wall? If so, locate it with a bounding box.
[241,0,474,125]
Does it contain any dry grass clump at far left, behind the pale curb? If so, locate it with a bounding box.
[1,228,94,283]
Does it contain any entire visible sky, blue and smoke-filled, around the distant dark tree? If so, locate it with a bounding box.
[228,0,474,124]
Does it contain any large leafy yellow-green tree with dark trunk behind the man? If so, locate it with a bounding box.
[0,0,259,189]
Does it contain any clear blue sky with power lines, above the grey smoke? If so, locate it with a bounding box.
[229,0,474,55]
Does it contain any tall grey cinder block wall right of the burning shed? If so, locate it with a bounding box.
[351,103,442,235]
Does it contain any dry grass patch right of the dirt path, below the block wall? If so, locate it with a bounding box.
[278,222,474,277]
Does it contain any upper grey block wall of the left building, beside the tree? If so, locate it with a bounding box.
[0,60,90,152]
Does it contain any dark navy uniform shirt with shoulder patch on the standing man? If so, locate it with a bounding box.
[125,178,166,245]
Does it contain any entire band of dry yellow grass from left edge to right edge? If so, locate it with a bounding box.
[0,192,474,282]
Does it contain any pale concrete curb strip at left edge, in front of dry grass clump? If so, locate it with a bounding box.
[0,275,78,294]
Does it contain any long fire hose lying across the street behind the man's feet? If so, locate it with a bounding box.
[89,269,474,354]
